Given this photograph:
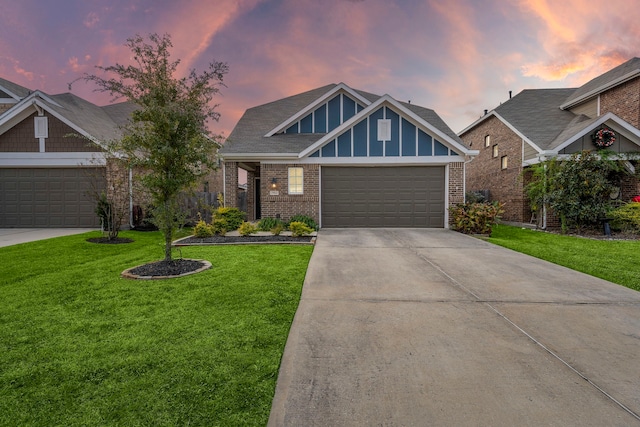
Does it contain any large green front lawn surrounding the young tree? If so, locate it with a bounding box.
[0,232,312,426]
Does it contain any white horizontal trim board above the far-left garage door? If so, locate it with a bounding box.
[0,152,106,168]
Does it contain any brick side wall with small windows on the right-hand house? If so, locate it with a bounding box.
[461,117,531,222]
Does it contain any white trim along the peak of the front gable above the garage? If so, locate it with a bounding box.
[298,95,480,158]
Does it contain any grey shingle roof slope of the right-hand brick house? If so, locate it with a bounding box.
[494,89,576,150]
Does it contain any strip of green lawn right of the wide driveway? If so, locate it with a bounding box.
[489,225,640,291]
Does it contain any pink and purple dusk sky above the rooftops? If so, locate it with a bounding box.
[0,0,640,135]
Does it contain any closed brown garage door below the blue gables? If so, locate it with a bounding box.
[321,166,445,227]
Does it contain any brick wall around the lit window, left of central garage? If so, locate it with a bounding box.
[260,164,320,222]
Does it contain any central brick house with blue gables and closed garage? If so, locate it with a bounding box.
[220,83,477,227]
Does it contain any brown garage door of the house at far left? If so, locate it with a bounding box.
[0,168,104,228]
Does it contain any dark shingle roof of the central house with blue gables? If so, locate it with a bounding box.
[221,84,464,155]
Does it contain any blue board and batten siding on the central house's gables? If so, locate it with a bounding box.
[285,94,458,158]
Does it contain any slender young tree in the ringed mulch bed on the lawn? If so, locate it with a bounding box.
[83,34,228,261]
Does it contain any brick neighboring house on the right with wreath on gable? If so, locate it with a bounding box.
[459,58,640,231]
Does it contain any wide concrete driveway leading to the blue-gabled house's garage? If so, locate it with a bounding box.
[269,229,640,426]
